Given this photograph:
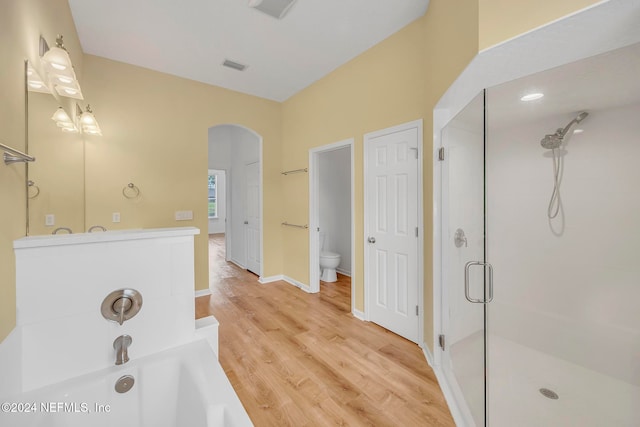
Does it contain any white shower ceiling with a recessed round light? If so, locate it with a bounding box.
[453,43,640,132]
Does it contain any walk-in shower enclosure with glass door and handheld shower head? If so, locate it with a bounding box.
[440,44,640,427]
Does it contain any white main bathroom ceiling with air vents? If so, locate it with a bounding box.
[69,0,429,101]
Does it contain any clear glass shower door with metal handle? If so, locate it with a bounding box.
[439,91,492,426]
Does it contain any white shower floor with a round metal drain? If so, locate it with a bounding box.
[451,335,640,427]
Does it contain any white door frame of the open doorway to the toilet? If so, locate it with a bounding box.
[309,138,356,313]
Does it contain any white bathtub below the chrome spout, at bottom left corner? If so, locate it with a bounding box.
[0,340,252,427]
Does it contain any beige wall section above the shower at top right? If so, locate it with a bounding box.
[478,0,602,50]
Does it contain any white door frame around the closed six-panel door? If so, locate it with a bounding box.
[362,119,425,349]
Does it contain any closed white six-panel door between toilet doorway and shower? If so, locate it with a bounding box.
[365,127,419,342]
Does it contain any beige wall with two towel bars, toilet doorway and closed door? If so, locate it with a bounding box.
[282,0,478,352]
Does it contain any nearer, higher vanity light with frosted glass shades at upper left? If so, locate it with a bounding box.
[40,35,84,99]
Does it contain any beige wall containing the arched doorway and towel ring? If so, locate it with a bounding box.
[83,55,282,289]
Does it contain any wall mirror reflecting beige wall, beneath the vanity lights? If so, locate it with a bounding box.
[25,60,85,235]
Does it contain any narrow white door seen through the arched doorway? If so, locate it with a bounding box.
[245,162,260,275]
